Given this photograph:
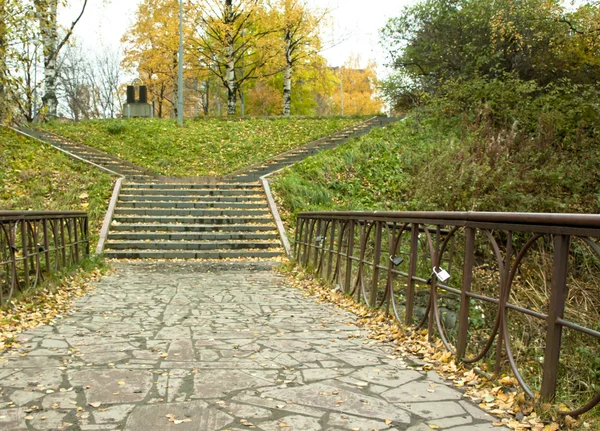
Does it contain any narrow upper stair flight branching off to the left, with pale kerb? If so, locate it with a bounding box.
[20,128,157,182]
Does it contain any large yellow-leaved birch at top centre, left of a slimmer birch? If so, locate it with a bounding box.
[194,0,278,115]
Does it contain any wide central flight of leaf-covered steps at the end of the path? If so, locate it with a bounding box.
[105,183,283,259]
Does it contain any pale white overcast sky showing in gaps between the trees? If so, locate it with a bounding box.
[59,0,416,77]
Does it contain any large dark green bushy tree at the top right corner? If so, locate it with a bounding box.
[381,0,600,109]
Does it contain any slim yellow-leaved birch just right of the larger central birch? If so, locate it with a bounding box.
[277,0,329,116]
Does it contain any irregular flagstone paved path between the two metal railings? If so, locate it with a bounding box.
[0,262,498,431]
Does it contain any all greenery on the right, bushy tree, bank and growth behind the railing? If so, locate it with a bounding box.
[273,0,600,429]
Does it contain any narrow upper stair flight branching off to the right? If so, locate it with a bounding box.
[224,117,400,182]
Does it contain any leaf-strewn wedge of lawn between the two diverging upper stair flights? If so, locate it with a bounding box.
[44,117,364,176]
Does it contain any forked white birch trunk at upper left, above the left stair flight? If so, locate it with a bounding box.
[34,0,87,119]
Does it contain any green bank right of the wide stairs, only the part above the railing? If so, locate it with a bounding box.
[273,116,600,228]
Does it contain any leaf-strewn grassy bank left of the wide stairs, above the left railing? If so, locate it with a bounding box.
[0,128,113,243]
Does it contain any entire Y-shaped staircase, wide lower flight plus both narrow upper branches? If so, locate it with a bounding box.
[21,117,398,259]
